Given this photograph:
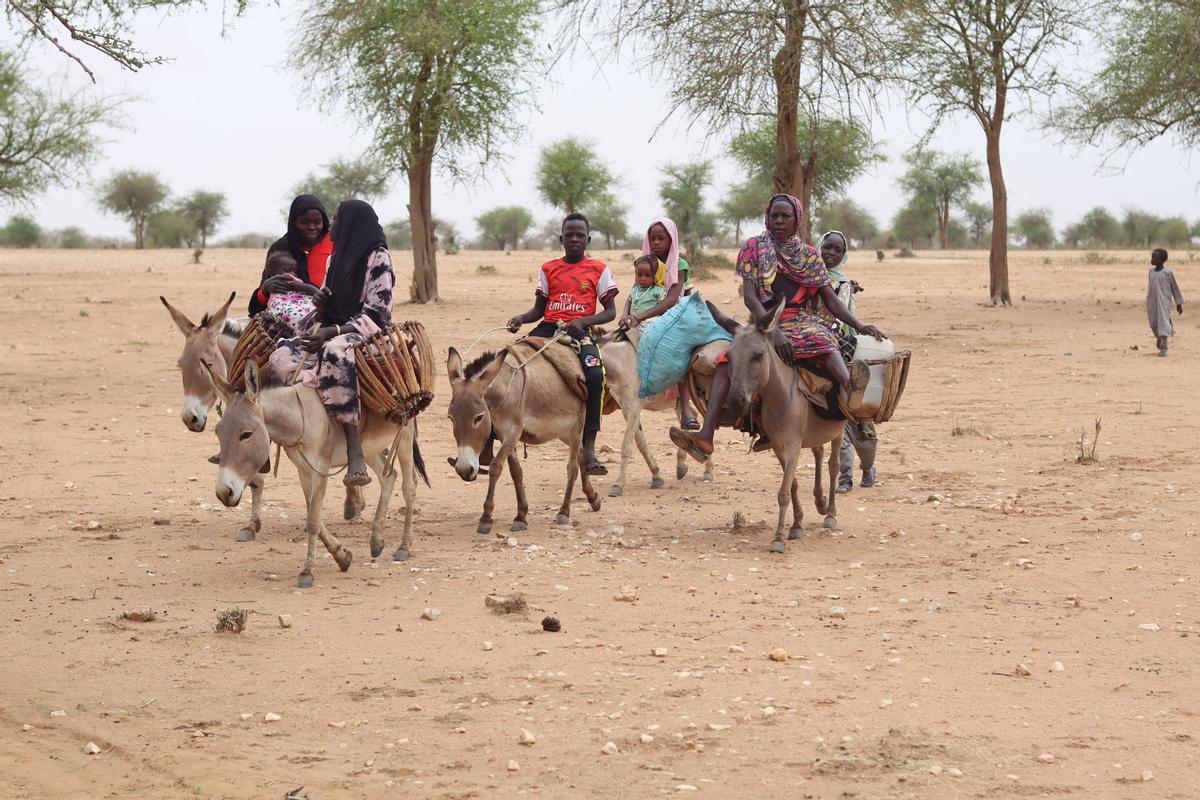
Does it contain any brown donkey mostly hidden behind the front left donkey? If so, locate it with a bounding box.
[158,291,366,542]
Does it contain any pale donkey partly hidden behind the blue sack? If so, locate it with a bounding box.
[599,333,713,498]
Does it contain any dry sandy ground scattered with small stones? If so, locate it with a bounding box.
[0,251,1200,800]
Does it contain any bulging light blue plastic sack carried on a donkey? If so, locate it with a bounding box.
[637,291,733,397]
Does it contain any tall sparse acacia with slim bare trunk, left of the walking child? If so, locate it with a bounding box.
[892,0,1093,306]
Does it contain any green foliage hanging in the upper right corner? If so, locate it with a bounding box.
[1055,0,1200,150]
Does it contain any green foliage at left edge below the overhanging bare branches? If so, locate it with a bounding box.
[0,50,121,203]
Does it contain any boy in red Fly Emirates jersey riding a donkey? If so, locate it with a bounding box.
[509,213,617,475]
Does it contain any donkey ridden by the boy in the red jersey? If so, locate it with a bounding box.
[446,344,600,534]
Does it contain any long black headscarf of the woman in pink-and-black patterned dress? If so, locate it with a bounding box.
[322,200,388,325]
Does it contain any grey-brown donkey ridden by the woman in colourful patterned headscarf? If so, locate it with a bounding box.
[709,303,845,553]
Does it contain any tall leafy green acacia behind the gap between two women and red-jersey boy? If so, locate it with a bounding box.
[297,0,539,302]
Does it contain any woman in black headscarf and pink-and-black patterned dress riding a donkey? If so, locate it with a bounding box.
[271,200,396,486]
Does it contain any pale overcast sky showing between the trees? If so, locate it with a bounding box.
[10,0,1200,244]
